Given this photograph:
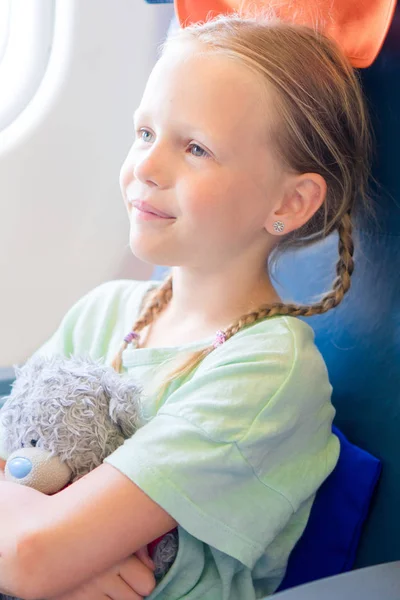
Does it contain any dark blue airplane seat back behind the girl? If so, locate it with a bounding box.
[270,7,400,567]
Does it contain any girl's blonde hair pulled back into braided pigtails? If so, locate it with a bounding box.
[113,9,371,394]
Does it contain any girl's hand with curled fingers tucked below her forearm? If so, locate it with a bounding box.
[47,546,156,600]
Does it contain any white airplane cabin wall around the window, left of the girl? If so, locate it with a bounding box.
[0,0,173,367]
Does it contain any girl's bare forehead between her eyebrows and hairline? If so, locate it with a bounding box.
[140,43,272,144]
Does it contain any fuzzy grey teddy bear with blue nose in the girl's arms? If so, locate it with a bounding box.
[0,356,178,600]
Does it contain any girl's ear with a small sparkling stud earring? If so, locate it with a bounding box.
[265,173,327,235]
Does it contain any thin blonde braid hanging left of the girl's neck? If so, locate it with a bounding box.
[111,274,172,373]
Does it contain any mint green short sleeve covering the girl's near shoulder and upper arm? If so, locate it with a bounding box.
[105,316,339,568]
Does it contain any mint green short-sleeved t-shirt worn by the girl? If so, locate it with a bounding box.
[0,280,339,600]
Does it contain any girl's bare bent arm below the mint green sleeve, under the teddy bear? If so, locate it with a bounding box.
[15,464,177,598]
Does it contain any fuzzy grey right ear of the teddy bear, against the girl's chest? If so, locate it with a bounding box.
[109,376,142,438]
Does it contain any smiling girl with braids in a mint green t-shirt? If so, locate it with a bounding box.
[0,8,370,600]
